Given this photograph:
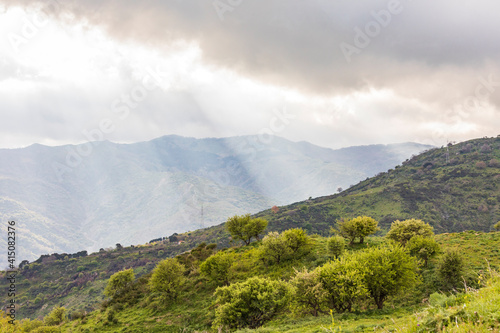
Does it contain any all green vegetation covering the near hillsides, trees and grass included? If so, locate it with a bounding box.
[0,139,500,332]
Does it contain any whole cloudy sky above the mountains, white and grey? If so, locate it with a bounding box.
[0,0,500,148]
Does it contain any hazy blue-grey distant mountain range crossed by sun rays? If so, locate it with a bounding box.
[0,136,430,260]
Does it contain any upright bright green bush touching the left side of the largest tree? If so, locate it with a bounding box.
[318,255,368,313]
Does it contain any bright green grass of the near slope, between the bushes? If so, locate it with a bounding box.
[53,232,500,333]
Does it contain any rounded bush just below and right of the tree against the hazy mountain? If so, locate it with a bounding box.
[261,229,311,264]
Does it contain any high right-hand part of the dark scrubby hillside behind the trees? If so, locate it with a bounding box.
[252,137,500,234]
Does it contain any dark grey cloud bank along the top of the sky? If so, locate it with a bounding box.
[2,0,500,94]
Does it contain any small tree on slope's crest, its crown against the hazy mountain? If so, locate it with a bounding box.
[226,214,267,245]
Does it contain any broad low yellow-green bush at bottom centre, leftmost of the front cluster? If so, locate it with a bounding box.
[213,277,291,329]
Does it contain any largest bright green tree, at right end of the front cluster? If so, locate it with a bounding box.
[358,244,420,309]
